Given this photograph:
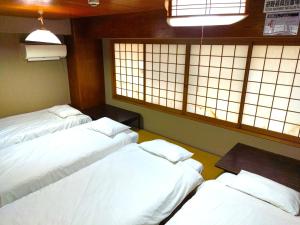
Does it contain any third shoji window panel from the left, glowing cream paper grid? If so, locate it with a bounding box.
[187,45,248,123]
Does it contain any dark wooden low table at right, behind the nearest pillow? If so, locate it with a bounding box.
[216,143,300,191]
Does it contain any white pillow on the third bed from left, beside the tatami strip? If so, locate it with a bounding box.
[140,139,193,163]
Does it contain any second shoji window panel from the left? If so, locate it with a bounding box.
[145,44,186,110]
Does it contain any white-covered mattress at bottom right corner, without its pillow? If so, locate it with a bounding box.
[167,179,300,225]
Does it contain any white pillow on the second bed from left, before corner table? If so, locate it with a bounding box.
[89,117,130,137]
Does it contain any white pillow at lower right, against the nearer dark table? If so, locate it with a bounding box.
[228,170,300,216]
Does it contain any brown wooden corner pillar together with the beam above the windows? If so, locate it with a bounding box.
[68,0,299,108]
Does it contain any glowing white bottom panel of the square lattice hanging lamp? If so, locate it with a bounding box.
[167,15,247,27]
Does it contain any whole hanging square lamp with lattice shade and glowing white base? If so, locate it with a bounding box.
[165,0,248,27]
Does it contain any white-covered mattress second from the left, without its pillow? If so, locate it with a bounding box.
[0,124,132,206]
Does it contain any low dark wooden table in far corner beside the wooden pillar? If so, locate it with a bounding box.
[82,104,141,129]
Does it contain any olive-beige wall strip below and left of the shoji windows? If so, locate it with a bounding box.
[103,39,300,160]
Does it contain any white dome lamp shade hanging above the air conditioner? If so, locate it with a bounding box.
[25,29,61,44]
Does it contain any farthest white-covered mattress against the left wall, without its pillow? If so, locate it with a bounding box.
[0,109,92,151]
